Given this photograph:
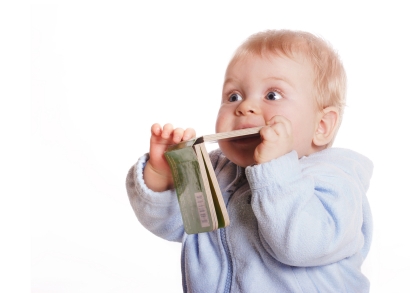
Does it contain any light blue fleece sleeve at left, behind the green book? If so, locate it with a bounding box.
[126,154,184,242]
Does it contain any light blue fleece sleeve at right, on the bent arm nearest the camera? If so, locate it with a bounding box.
[246,150,372,266]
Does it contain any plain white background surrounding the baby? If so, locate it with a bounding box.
[23,0,410,293]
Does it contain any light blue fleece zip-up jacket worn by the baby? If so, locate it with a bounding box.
[127,148,373,293]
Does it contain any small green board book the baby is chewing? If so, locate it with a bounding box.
[165,127,261,234]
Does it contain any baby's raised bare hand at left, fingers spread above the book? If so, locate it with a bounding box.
[144,123,196,191]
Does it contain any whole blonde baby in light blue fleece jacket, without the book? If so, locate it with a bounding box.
[127,30,373,293]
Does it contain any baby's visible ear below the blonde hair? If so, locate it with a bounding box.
[313,106,339,147]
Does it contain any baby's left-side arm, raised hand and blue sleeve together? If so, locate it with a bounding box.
[126,124,195,241]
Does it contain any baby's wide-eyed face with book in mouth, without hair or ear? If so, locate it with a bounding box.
[216,54,319,167]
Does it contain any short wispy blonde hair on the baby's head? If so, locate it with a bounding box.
[229,30,347,120]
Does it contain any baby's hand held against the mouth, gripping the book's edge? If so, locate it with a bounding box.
[254,115,293,164]
